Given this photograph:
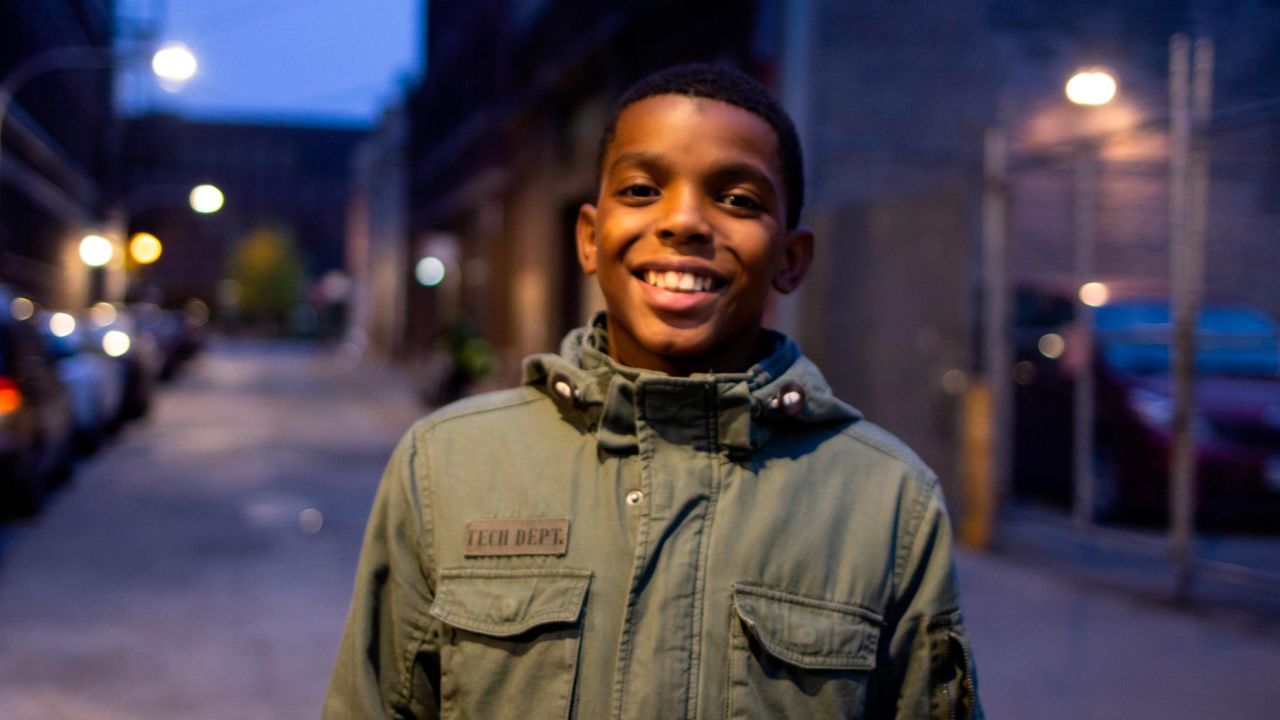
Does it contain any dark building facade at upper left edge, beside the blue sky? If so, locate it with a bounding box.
[0,0,116,307]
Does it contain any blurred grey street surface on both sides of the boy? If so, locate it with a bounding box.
[0,340,1280,720]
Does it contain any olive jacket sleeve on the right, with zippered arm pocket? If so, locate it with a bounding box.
[870,475,983,720]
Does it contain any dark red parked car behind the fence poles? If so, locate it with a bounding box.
[1014,286,1280,529]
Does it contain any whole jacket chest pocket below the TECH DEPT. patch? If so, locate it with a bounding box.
[431,569,591,720]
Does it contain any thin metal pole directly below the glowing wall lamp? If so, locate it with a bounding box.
[1069,143,1098,527]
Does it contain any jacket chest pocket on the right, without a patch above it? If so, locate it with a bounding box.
[724,583,881,719]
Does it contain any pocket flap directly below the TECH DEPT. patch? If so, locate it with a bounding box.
[431,569,591,638]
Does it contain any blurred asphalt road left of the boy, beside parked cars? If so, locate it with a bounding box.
[0,342,421,720]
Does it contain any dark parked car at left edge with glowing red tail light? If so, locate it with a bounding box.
[0,287,74,515]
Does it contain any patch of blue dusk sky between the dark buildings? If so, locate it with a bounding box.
[119,0,422,124]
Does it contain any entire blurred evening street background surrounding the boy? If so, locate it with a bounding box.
[0,0,1280,719]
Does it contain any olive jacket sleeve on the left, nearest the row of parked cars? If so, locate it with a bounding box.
[323,427,439,720]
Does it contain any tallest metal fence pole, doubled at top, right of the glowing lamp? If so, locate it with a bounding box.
[1169,35,1213,600]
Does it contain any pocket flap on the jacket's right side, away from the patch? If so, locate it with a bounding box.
[733,583,881,670]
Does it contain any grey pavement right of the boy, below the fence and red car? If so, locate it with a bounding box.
[957,507,1280,720]
